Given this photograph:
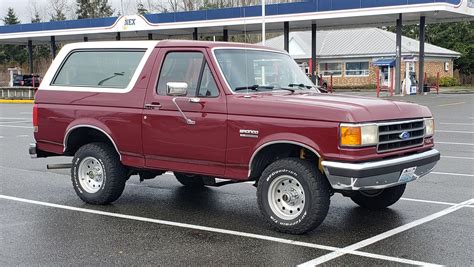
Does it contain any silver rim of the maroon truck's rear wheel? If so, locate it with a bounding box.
[78,157,104,194]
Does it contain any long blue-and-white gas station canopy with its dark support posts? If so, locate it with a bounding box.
[0,0,474,93]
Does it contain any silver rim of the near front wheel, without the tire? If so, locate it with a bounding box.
[268,175,306,220]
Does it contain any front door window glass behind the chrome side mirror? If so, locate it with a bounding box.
[158,52,204,96]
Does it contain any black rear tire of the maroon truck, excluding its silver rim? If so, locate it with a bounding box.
[71,143,127,205]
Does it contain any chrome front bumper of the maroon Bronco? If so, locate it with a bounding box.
[321,149,440,190]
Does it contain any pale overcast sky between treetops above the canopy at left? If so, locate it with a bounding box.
[0,0,156,25]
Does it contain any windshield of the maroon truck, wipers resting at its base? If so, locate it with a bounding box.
[215,49,315,92]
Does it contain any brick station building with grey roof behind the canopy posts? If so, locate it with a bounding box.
[266,28,460,88]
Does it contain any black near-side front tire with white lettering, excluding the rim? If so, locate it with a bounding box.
[257,158,330,234]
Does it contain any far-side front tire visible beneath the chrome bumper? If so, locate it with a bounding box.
[351,184,406,210]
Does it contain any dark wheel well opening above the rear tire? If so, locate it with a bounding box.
[64,127,118,156]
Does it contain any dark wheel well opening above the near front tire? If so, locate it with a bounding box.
[250,143,319,179]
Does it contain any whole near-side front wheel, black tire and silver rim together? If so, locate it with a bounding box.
[257,158,330,234]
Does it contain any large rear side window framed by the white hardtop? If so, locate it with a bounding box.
[51,50,145,89]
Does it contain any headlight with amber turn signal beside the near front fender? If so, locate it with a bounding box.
[339,123,379,147]
